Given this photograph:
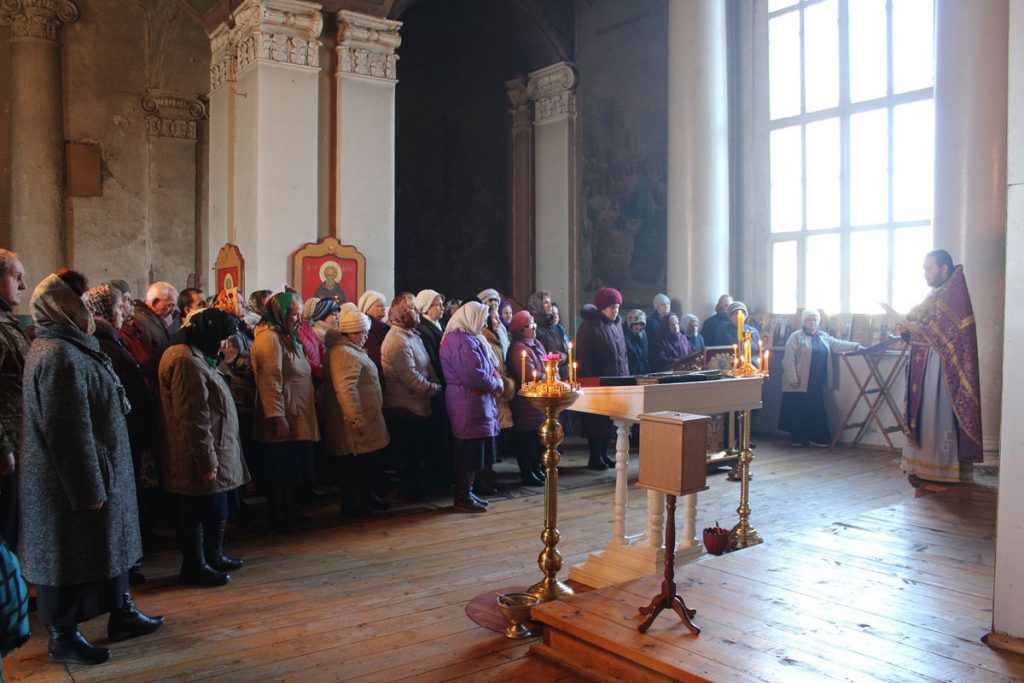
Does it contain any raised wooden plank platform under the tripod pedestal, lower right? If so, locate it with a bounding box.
[534,488,1024,682]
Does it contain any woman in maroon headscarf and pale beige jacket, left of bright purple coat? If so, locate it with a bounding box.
[381,292,441,502]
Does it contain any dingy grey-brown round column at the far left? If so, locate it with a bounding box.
[2,0,78,299]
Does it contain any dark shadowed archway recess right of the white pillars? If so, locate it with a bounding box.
[391,0,573,299]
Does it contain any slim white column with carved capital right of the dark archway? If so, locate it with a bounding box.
[526,61,580,330]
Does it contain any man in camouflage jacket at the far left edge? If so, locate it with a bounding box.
[0,249,29,548]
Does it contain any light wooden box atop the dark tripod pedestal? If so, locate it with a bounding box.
[637,411,711,496]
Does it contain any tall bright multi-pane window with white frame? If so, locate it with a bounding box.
[762,0,935,313]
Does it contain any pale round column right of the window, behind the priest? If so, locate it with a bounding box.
[935,0,1009,460]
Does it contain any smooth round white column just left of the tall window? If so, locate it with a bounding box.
[668,0,729,312]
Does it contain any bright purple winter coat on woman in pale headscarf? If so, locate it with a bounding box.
[440,330,502,439]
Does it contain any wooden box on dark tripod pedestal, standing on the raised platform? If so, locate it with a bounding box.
[637,411,711,635]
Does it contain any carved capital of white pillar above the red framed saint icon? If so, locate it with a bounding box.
[338,9,401,81]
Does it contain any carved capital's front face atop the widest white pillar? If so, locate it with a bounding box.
[234,0,324,72]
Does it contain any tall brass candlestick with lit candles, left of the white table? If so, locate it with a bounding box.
[519,354,583,602]
